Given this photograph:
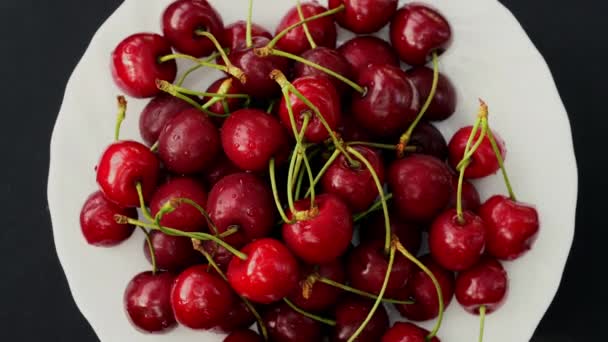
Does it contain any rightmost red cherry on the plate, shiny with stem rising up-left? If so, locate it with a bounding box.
[479,195,540,260]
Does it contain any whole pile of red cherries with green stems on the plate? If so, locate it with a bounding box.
[80,0,539,342]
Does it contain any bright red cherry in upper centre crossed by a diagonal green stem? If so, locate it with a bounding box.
[278,76,341,143]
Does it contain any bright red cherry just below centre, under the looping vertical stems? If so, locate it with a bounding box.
[283,194,353,264]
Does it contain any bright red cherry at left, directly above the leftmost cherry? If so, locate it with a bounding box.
[97,141,160,207]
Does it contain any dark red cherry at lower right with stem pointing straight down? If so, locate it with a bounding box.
[456,256,509,315]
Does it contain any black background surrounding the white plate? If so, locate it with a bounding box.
[0,0,608,342]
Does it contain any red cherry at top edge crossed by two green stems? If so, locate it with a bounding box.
[275,2,338,55]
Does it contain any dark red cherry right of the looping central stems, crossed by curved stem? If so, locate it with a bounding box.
[321,145,384,213]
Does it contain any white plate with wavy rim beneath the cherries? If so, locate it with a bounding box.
[48,0,577,342]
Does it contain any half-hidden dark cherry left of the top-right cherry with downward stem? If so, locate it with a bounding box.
[338,36,399,74]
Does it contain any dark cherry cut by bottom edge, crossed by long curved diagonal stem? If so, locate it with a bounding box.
[331,297,389,342]
